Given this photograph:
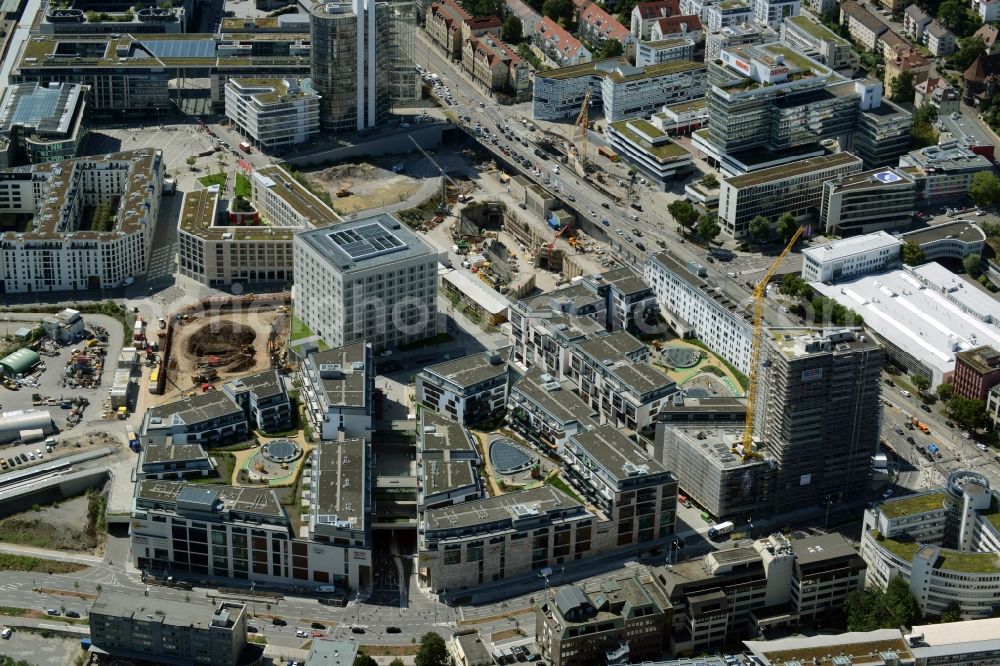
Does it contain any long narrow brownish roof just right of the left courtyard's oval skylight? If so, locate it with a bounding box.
[311,439,368,530]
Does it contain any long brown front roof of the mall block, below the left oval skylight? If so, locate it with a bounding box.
[136,479,286,518]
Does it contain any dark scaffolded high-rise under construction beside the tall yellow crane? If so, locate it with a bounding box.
[759,329,885,506]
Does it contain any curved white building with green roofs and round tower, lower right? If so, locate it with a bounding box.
[861,470,1000,619]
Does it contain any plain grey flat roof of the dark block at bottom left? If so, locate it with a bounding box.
[90,591,246,630]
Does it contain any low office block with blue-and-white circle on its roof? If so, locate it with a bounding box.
[810,168,917,235]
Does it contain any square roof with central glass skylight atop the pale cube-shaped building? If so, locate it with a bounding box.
[295,213,437,273]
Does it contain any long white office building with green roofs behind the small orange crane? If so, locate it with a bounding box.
[531,58,705,122]
